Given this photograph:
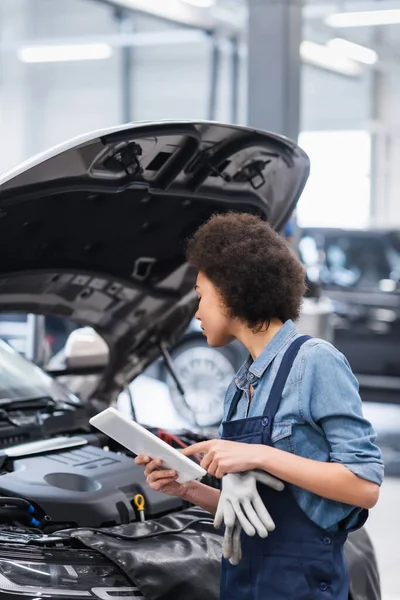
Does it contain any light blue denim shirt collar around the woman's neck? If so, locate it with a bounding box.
[236,319,299,387]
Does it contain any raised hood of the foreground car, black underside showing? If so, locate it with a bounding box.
[0,122,309,399]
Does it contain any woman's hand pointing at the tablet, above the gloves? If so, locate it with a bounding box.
[181,440,267,479]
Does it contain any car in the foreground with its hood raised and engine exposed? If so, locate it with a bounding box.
[0,122,378,600]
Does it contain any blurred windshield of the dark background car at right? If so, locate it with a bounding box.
[299,230,400,291]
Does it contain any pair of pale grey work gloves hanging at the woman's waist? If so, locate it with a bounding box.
[214,471,285,565]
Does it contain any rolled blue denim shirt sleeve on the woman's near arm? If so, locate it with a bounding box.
[301,341,384,485]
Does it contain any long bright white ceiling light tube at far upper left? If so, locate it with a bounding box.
[17,43,113,63]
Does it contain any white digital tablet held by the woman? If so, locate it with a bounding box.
[89,408,207,483]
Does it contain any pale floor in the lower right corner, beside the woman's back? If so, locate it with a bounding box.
[366,478,400,600]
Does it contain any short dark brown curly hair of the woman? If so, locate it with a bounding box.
[187,213,306,331]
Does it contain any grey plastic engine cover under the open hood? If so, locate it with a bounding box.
[0,446,182,527]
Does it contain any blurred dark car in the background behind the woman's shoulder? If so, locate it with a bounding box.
[299,227,400,403]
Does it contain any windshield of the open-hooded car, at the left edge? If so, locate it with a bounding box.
[0,340,79,404]
